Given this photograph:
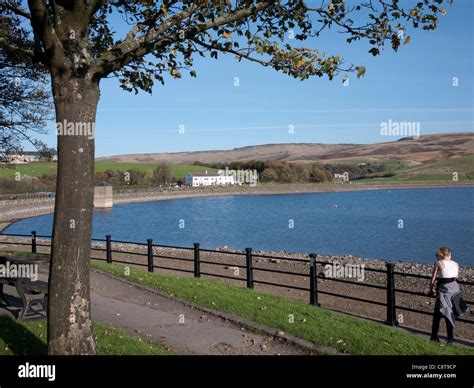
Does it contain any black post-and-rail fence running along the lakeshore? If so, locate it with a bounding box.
[0,231,474,326]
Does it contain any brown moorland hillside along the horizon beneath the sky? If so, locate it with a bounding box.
[98,132,474,165]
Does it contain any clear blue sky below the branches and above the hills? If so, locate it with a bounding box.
[36,0,474,156]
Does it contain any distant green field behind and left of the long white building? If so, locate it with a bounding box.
[0,162,216,179]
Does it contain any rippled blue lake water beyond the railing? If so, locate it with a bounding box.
[6,188,474,266]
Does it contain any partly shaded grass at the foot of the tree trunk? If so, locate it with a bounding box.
[0,317,171,356]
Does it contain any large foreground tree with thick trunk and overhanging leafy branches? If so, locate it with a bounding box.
[2,0,452,354]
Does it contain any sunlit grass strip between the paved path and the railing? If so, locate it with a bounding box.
[91,261,474,355]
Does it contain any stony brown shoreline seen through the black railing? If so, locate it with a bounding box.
[0,236,474,344]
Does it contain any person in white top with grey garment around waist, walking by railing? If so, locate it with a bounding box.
[430,247,460,343]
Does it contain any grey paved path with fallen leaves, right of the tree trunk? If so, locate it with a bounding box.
[91,272,304,355]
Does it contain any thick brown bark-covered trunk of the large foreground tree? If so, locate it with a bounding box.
[48,67,99,355]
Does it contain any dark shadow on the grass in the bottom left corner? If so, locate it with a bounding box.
[0,317,47,356]
